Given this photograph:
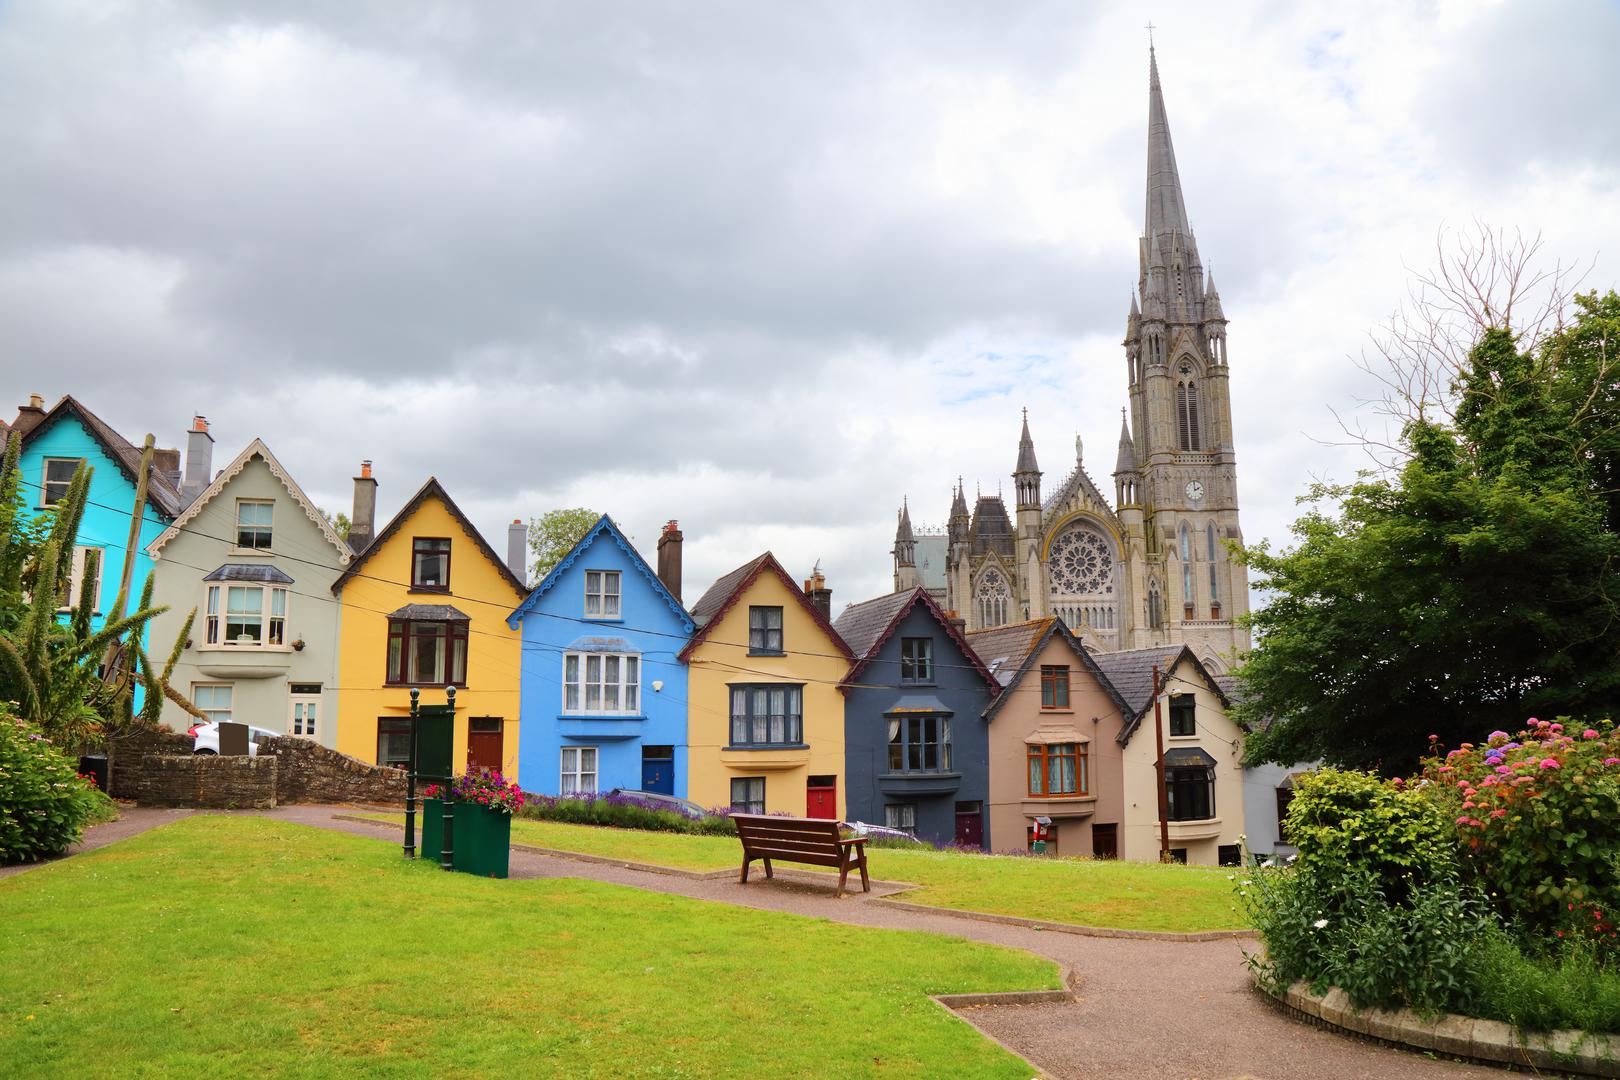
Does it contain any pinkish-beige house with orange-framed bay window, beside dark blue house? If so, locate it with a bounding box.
[967,615,1128,858]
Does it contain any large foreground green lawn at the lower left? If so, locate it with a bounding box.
[0,816,1058,1080]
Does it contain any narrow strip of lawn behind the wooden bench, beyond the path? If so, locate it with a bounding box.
[366,814,1246,933]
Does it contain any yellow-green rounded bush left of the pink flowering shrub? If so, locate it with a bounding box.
[1285,769,1456,900]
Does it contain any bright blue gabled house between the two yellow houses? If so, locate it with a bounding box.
[507,515,695,798]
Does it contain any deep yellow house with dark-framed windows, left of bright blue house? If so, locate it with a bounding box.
[332,476,527,779]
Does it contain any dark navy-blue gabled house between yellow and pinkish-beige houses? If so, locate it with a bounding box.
[833,588,1001,847]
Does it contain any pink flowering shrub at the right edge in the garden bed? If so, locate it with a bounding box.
[1422,719,1620,950]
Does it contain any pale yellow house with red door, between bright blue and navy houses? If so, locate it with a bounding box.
[680,552,855,819]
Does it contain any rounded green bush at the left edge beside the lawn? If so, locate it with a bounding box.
[0,704,103,865]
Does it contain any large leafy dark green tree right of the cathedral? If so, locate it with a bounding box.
[1238,329,1620,771]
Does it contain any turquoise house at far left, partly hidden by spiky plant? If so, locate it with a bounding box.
[6,395,181,628]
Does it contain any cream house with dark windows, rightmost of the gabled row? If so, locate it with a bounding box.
[1095,644,1244,866]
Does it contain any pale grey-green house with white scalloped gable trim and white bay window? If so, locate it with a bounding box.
[147,439,352,746]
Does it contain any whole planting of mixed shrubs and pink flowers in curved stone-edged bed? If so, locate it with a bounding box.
[1234,721,1620,1033]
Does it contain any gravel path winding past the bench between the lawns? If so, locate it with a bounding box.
[266,806,1503,1080]
